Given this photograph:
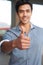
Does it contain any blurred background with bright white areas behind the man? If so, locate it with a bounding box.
[0,0,43,65]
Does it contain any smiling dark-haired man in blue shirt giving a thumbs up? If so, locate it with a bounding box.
[1,0,43,65]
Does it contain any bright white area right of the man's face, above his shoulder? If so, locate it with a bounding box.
[31,4,43,28]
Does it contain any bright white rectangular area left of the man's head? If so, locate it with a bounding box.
[0,1,11,28]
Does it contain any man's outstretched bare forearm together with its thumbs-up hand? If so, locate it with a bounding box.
[1,29,30,52]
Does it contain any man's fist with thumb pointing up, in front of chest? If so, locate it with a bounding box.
[12,27,30,50]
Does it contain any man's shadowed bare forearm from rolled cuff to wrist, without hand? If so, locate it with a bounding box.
[1,41,16,53]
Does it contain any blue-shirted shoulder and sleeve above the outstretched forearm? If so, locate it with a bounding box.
[3,26,18,40]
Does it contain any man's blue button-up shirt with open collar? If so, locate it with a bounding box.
[3,24,43,65]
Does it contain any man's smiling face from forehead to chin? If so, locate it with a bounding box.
[18,4,32,24]
